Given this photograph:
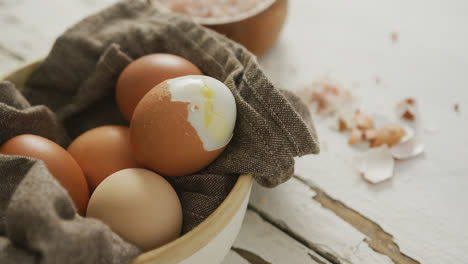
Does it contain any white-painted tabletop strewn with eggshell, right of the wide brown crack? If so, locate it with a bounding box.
[265,0,468,263]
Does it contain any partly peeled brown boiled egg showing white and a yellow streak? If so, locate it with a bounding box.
[130,75,237,176]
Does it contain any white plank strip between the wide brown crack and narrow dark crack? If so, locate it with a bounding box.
[250,178,392,264]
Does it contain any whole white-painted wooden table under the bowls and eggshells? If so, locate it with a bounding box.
[0,0,468,264]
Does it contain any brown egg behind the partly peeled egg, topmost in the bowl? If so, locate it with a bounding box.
[115,53,202,122]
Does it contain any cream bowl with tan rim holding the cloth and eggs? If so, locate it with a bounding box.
[1,61,252,264]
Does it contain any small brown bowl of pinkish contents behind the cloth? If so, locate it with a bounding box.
[158,0,288,56]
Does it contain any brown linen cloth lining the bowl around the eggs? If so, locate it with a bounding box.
[0,0,319,263]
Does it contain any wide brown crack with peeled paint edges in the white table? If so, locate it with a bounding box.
[294,175,420,264]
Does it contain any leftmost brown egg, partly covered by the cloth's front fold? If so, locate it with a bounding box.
[0,134,89,215]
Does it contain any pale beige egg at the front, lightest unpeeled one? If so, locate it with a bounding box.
[86,168,182,251]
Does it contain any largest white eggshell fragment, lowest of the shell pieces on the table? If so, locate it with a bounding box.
[355,145,395,184]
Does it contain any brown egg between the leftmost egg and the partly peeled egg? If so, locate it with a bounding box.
[68,126,139,192]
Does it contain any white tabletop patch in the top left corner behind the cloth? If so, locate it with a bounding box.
[0,0,115,75]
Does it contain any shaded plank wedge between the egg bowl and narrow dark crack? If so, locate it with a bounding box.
[229,210,330,264]
